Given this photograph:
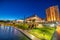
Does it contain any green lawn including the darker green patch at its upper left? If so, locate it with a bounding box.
[18,24,56,40]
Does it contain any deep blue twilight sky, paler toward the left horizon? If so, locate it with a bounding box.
[0,0,60,20]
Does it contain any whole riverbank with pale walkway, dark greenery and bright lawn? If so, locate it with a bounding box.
[0,24,55,40]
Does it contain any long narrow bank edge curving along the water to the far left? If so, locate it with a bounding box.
[1,24,40,40]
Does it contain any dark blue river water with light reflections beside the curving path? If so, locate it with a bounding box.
[0,26,29,40]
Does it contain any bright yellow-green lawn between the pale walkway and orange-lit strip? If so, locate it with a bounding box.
[29,26,55,40]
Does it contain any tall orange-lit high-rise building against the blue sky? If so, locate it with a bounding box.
[46,6,59,22]
